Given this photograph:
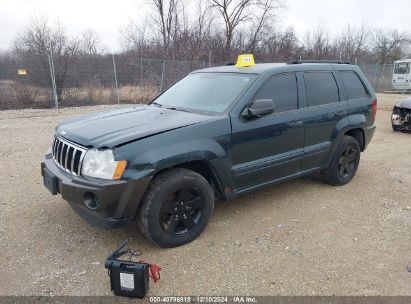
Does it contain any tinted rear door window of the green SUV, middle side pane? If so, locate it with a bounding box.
[304,72,340,107]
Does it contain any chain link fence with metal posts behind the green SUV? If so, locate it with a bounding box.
[0,54,406,110]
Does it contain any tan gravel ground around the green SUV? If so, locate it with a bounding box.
[0,95,411,295]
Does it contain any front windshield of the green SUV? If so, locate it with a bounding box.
[154,73,256,113]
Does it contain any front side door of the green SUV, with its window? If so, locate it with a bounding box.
[231,73,305,189]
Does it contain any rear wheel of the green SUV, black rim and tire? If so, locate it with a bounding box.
[321,135,361,186]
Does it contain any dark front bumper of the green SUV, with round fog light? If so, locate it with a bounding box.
[41,154,151,229]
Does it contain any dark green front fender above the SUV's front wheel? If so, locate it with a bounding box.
[116,119,232,194]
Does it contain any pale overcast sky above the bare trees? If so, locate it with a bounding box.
[0,0,411,52]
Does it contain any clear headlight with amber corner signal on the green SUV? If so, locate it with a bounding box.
[81,149,127,179]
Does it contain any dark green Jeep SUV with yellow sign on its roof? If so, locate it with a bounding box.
[41,61,377,247]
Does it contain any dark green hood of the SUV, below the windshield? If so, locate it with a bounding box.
[56,106,216,148]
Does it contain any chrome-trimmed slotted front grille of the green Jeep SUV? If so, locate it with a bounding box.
[52,137,86,175]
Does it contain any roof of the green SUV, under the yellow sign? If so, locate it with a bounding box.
[193,62,353,75]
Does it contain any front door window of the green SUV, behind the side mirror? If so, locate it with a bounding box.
[254,73,298,113]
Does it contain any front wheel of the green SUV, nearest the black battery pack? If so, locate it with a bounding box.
[137,168,214,248]
